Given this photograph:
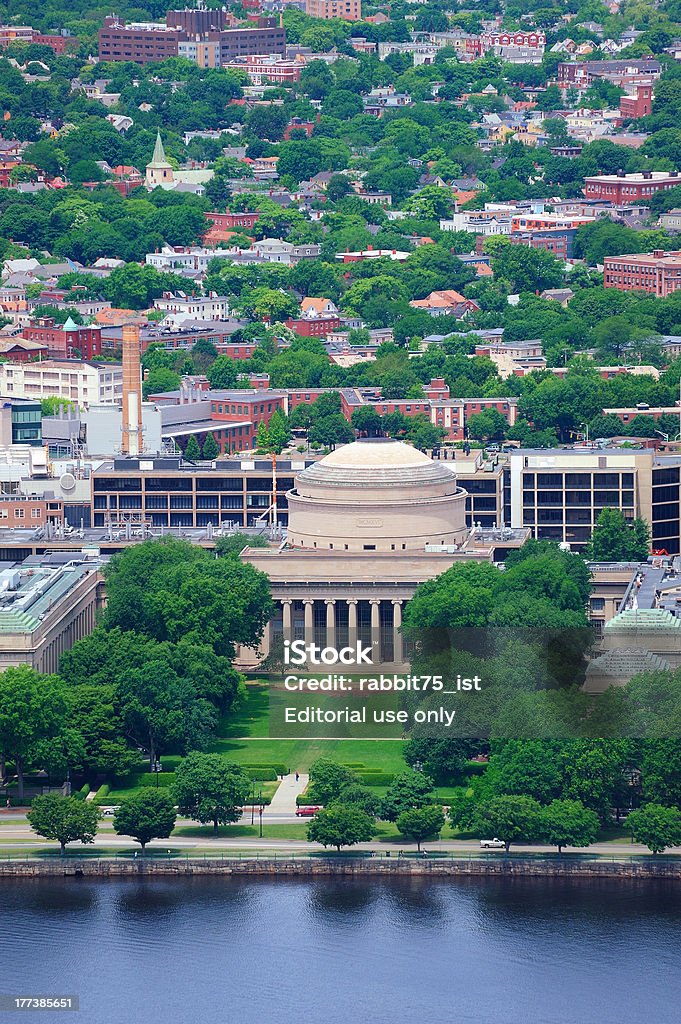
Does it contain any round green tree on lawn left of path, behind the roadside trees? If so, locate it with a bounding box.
[173,751,251,831]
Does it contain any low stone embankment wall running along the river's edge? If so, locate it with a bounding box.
[0,856,681,881]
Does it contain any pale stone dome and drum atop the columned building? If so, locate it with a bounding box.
[288,437,467,552]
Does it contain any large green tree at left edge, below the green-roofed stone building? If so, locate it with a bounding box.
[0,665,68,800]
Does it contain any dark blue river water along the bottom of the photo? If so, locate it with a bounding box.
[0,878,681,1024]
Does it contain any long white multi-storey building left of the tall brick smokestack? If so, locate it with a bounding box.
[0,359,123,407]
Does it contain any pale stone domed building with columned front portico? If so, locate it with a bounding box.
[240,437,509,669]
